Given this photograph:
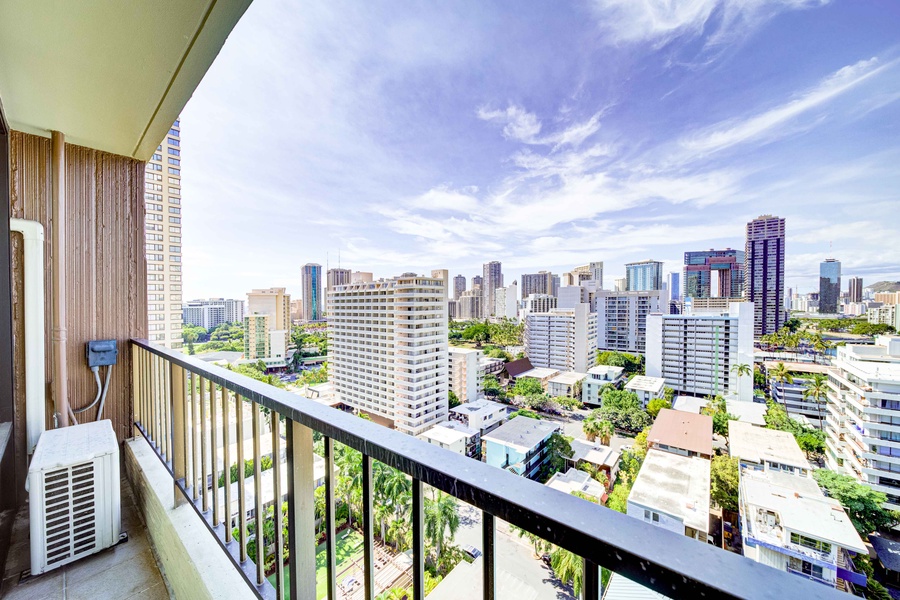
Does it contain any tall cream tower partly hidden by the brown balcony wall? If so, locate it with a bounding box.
[144,119,183,349]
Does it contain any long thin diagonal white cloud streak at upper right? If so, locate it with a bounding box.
[681,58,884,154]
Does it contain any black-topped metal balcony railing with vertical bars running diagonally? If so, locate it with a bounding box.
[131,340,841,600]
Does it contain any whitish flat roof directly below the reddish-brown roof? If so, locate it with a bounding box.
[628,448,709,532]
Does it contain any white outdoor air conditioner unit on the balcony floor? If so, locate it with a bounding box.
[27,420,122,575]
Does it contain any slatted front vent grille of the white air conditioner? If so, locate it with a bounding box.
[44,461,97,566]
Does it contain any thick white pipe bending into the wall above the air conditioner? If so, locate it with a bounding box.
[9,219,47,455]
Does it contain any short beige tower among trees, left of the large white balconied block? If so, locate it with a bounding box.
[244,288,291,367]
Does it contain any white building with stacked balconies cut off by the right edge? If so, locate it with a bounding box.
[825,336,900,510]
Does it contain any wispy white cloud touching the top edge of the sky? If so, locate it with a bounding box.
[594,0,828,45]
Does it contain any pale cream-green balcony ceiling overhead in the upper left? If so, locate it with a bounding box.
[0,0,251,160]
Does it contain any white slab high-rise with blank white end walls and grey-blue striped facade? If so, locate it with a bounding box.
[646,302,753,401]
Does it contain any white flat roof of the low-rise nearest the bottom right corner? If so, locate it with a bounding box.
[740,469,867,552]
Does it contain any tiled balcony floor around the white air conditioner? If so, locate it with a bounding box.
[2,477,171,600]
